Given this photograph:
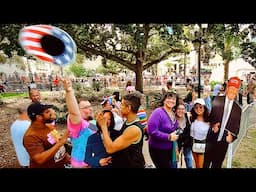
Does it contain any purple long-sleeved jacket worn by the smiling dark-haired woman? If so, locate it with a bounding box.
[148,107,178,149]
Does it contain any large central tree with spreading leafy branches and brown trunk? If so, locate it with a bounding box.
[59,24,183,91]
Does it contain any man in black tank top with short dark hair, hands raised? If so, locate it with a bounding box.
[96,93,145,168]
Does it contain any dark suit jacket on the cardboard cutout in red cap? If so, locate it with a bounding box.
[207,96,242,142]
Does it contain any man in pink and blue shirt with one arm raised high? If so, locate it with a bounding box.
[63,79,97,168]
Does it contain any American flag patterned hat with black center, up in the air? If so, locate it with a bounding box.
[19,25,76,65]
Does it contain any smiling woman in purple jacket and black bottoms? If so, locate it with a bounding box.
[148,92,178,168]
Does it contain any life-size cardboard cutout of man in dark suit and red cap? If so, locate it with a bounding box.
[203,77,242,168]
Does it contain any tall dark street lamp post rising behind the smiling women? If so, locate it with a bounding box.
[193,24,208,98]
